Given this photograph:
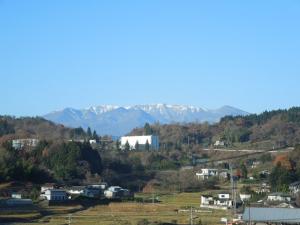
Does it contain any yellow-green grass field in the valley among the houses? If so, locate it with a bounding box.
[0,193,230,225]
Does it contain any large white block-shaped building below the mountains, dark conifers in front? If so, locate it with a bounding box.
[121,135,159,150]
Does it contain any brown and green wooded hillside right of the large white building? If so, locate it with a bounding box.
[131,107,300,149]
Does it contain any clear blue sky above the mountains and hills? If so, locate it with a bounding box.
[0,0,300,116]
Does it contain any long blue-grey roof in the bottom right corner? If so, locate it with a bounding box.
[243,207,300,224]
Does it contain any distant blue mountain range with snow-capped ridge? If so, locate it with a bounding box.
[44,104,249,136]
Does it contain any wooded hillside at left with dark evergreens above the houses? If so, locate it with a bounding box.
[0,116,102,183]
